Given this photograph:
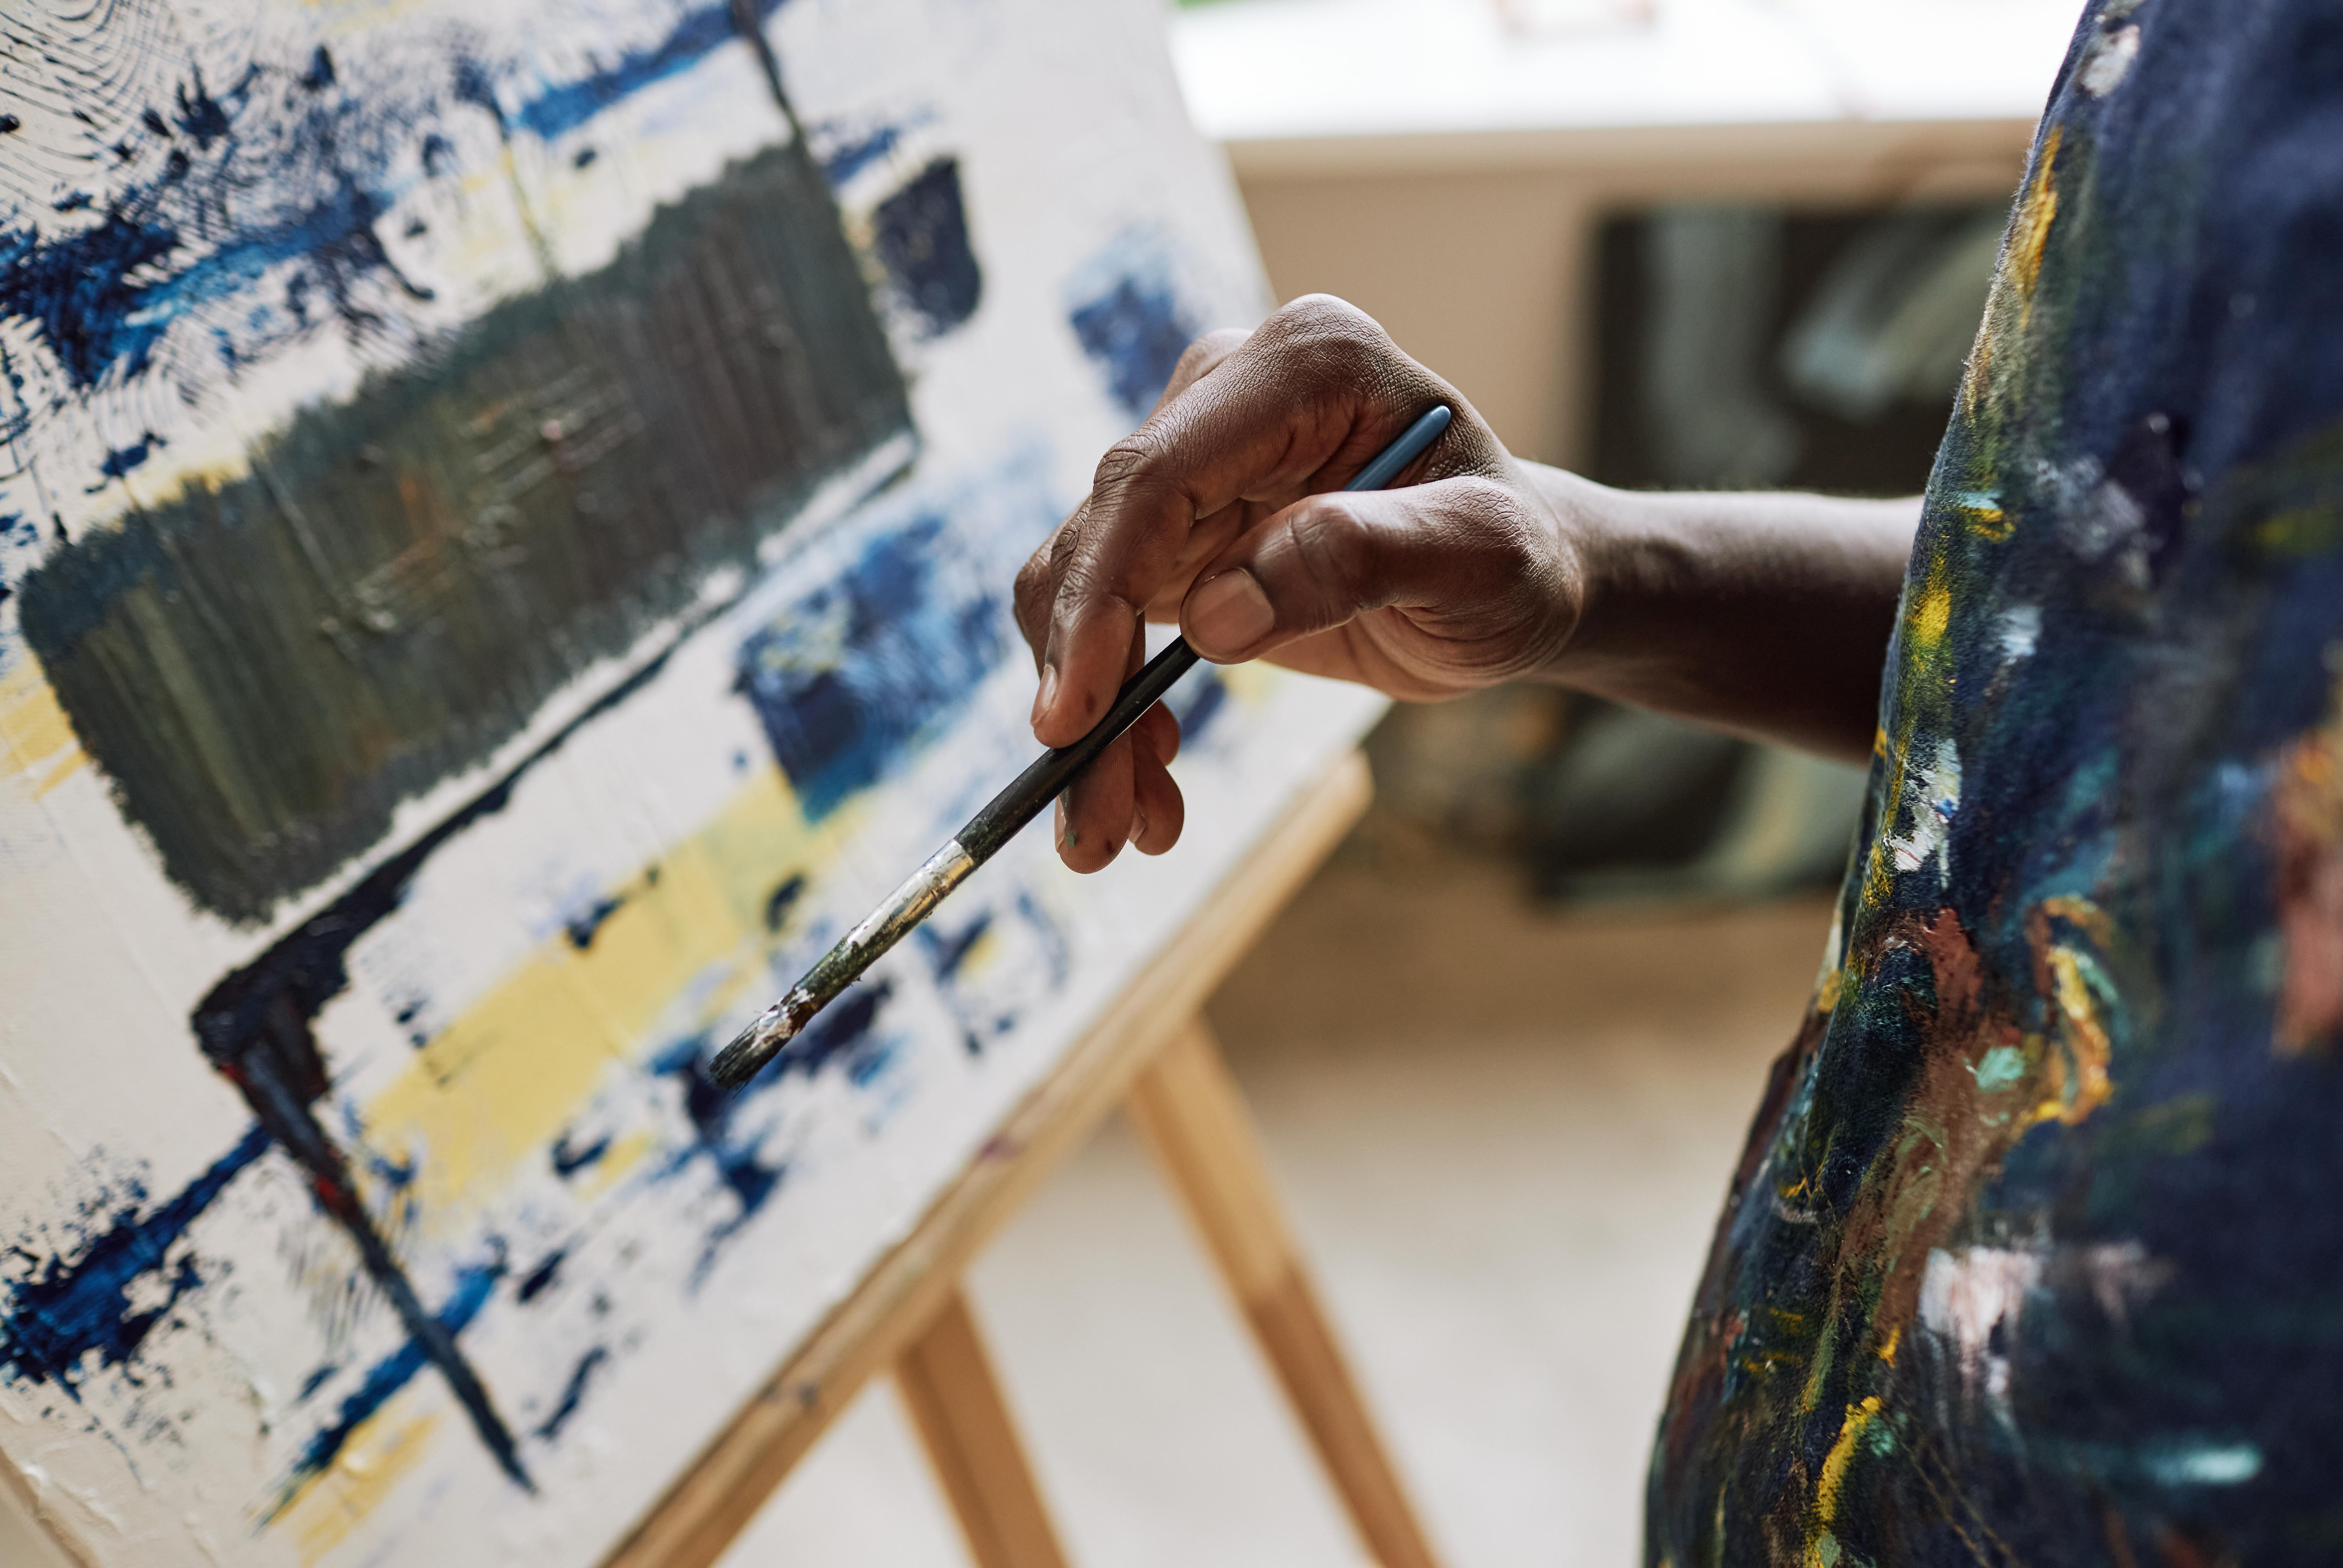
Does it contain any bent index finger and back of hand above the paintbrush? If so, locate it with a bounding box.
[1019,298,1504,746]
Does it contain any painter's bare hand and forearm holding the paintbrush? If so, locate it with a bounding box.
[1017,295,1919,872]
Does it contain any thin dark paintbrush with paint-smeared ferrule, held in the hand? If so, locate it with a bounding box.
[708,403,1453,1087]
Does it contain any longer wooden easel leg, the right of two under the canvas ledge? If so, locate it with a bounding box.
[1125,1020,1436,1568]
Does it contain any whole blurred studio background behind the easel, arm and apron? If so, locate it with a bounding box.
[729,0,2076,1568]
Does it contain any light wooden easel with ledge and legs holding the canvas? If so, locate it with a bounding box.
[604,755,1436,1568]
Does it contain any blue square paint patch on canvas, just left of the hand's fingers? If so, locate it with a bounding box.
[733,513,1005,822]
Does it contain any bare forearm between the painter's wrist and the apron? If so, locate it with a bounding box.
[1523,464,1919,760]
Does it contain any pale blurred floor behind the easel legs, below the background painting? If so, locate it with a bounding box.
[724,846,1827,1568]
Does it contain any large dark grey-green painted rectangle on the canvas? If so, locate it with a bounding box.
[21,141,909,921]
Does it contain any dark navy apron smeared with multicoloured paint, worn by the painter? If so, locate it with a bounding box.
[1645,0,2343,1568]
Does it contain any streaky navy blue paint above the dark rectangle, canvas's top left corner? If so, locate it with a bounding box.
[0,0,783,434]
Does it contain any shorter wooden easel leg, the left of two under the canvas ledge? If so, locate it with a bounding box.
[895,1292,1066,1568]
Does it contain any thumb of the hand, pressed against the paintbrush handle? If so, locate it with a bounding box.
[1181,478,1539,663]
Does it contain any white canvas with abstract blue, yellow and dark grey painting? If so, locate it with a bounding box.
[0,0,1375,1566]
